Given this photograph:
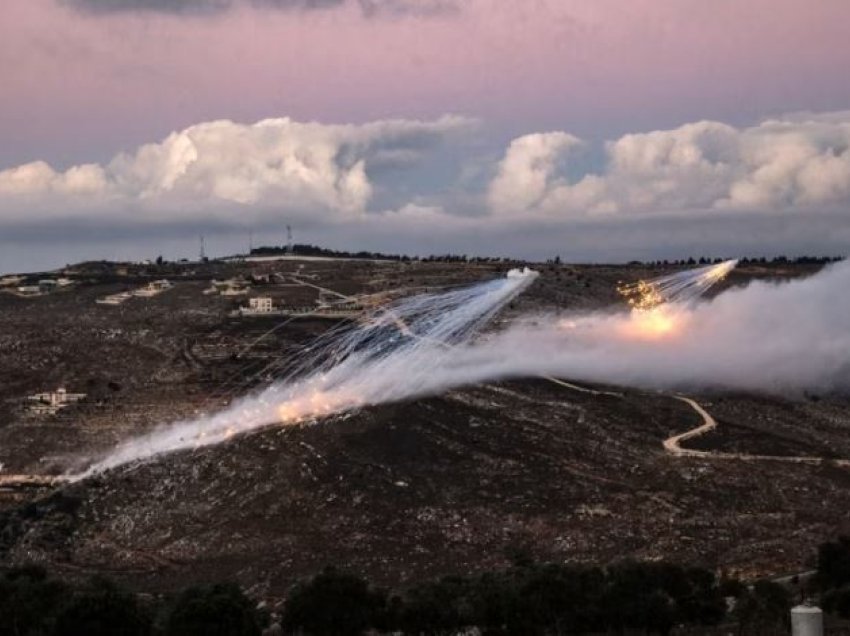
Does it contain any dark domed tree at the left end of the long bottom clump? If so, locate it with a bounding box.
[282,568,386,636]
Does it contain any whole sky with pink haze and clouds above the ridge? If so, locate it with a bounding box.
[0,0,850,272]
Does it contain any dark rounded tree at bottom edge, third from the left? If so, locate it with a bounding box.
[165,583,262,636]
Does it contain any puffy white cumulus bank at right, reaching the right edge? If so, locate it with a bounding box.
[488,112,850,218]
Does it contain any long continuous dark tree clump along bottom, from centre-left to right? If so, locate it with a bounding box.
[283,562,728,635]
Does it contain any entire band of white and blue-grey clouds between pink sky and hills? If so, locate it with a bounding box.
[0,113,850,268]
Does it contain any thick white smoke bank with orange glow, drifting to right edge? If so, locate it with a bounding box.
[436,261,850,395]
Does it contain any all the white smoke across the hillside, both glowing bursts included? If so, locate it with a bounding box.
[74,261,850,478]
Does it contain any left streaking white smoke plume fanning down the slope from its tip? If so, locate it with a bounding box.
[74,269,537,478]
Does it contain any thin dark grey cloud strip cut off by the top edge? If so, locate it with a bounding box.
[58,0,463,17]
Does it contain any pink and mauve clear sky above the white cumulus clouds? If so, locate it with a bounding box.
[0,0,850,168]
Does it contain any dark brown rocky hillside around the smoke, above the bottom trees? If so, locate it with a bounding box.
[0,261,850,597]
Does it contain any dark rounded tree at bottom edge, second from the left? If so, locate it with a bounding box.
[53,578,152,636]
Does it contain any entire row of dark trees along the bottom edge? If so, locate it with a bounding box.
[11,537,850,636]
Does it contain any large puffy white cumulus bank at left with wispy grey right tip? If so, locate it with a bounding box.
[0,116,473,224]
